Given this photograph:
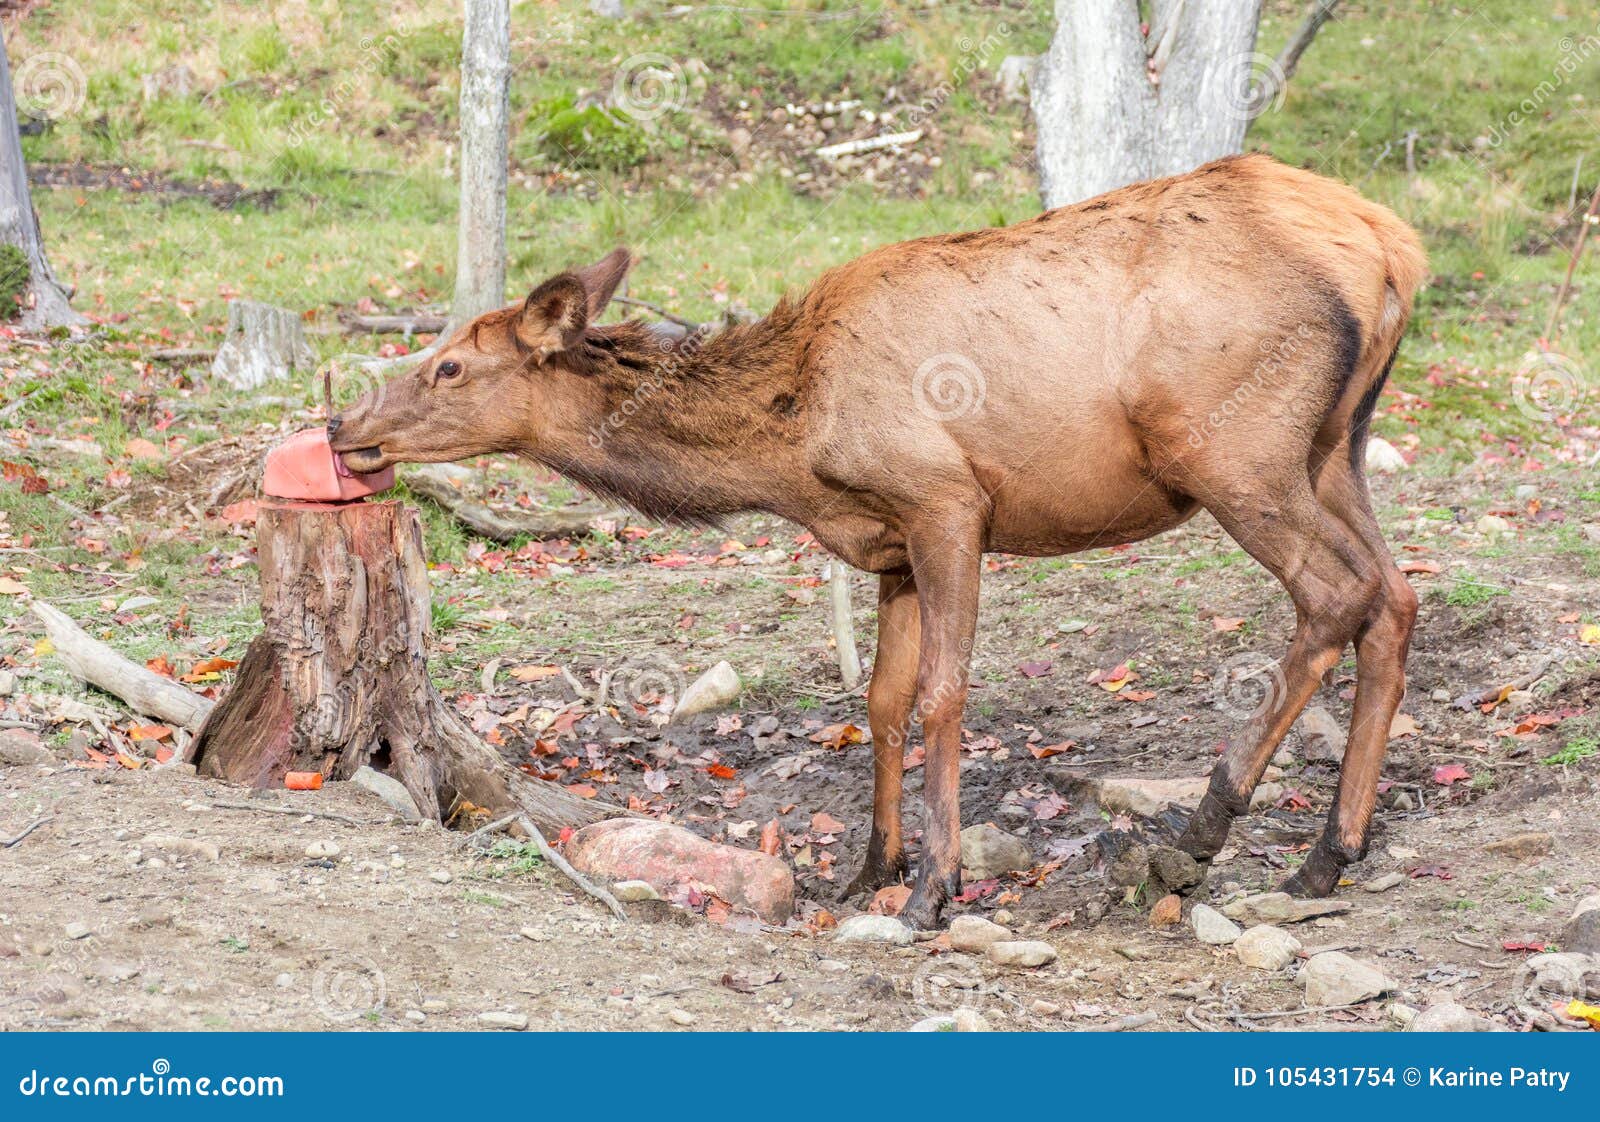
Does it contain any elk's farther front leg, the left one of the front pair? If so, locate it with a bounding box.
[840,571,922,900]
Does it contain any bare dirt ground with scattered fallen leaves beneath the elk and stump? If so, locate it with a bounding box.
[0,469,1600,1029]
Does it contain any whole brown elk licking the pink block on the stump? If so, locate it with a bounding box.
[330,155,1426,925]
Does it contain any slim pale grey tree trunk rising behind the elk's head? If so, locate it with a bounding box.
[450,0,510,325]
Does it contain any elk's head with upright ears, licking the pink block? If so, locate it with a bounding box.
[328,248,634,474]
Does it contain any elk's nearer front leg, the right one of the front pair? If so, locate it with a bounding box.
[901,527,982,928]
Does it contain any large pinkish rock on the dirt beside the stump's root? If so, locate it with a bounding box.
[566,818,795,924]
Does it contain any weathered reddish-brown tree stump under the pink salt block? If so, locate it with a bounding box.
[189,501,624,831]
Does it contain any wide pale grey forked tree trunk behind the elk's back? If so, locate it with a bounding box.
[1032,0,1262,208]
